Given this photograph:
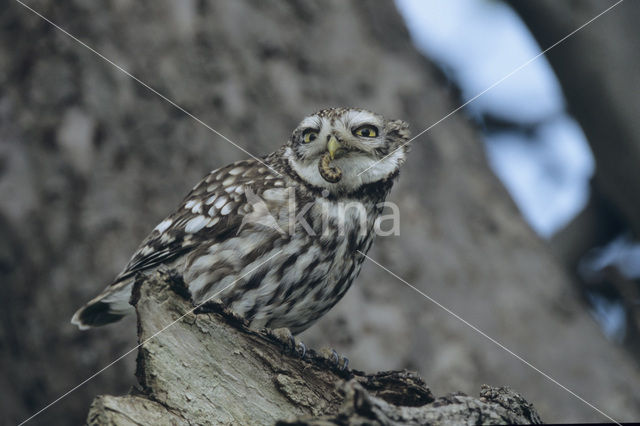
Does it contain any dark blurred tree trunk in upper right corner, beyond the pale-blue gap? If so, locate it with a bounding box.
[510,0,640,246]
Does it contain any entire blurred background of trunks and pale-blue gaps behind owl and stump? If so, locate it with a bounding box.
[0,0,640,424]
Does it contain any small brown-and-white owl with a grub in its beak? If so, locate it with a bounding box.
[71,108,409,334]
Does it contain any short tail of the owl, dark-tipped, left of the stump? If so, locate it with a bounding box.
[71,279,134,330]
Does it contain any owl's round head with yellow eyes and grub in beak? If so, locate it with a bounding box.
[284,108,410,193]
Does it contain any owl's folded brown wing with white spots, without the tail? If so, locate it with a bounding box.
[113,160,284,285]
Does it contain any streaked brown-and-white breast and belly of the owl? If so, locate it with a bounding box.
[184,193,379,333]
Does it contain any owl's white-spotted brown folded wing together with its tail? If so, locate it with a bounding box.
[71,160,285,329]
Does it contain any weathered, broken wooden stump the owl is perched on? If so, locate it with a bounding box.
[87,272,540,425]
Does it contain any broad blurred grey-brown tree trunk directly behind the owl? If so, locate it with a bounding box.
[0,0,640,424]
